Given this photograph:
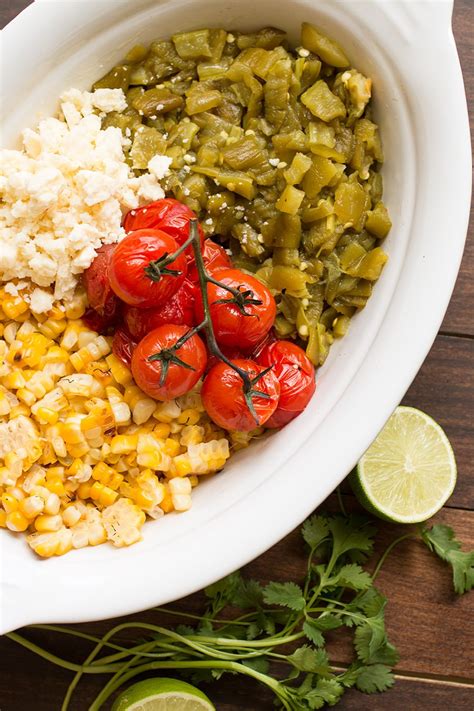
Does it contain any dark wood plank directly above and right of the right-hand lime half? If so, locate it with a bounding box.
[403,336,474,509]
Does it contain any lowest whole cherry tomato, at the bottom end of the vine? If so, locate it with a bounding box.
[201,359,280,432]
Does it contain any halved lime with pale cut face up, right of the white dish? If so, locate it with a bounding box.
[351,407,456,523]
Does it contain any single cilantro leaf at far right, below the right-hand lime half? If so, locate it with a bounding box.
[421,523,474,595]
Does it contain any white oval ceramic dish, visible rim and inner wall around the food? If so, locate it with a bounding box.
[0,0,471,632]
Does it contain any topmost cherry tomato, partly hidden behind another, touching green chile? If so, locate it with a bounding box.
[123,198,204,245]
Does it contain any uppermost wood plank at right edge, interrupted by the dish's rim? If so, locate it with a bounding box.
[441,0,474,336]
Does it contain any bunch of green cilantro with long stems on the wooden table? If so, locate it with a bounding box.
[8,513,474,711]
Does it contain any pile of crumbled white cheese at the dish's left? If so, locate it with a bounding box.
[0,89,169,302]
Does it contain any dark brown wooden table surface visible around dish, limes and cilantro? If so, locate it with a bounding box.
[0,0,474,711]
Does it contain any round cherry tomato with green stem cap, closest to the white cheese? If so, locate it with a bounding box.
[108,229,187,308]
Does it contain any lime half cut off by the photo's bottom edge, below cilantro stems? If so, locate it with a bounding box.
[112,677,215,711]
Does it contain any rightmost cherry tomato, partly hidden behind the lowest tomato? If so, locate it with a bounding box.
[257,341,316,427]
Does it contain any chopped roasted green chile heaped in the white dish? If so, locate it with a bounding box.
[94,23,392,366]
